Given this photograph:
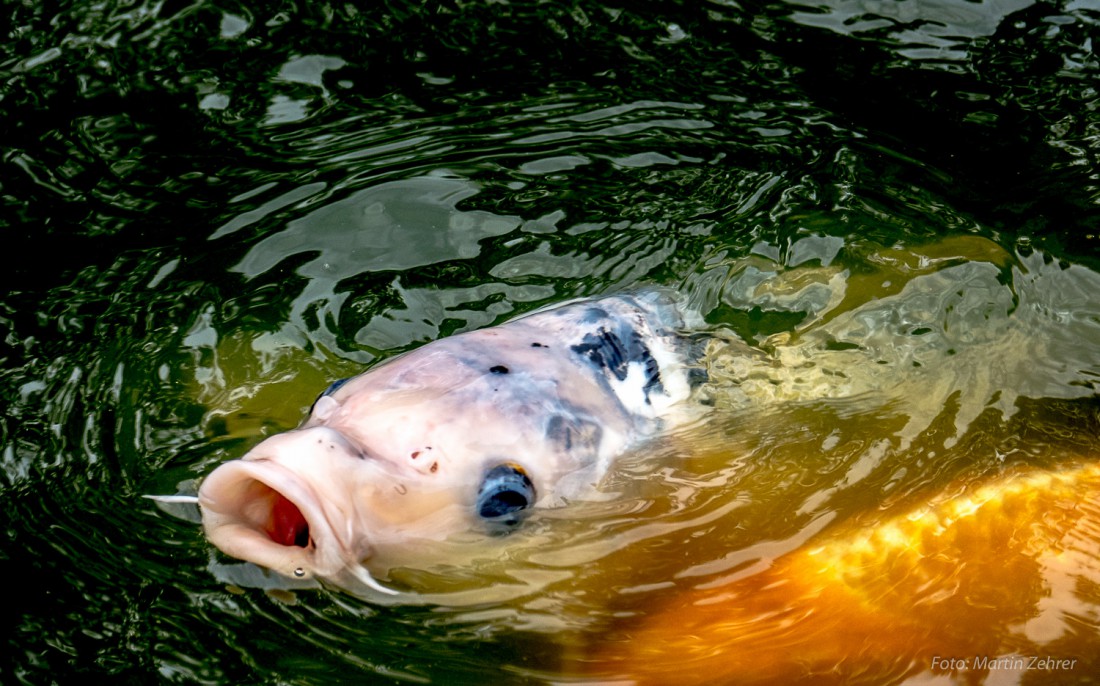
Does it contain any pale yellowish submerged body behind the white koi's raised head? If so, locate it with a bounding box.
[711,237,1100,446]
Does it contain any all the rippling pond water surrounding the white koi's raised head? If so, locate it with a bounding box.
[0,0,1100,684]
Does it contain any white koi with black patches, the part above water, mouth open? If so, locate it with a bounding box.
[198,291,690,593]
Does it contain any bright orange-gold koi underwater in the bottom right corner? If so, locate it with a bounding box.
[580,456,1100,684]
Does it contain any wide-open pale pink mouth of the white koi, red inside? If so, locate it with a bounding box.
[199,457,395,594]
